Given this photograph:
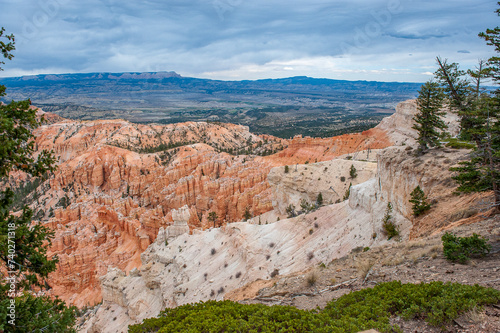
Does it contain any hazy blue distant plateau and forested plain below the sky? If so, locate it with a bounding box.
[0,72,421,136]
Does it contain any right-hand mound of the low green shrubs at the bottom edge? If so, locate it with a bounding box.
[323,281,500,332]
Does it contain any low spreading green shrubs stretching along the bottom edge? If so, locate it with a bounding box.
[129,281,500,333]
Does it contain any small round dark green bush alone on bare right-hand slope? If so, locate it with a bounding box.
[441,233,491,264]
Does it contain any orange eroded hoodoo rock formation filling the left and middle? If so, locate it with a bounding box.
[18,110,391,306]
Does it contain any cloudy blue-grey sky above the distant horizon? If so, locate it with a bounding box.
[0,0,500,82]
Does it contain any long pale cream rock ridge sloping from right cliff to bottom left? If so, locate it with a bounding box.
[87,141,472,332]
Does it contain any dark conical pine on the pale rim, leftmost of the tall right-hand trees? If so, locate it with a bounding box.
[413,81,447,154]
